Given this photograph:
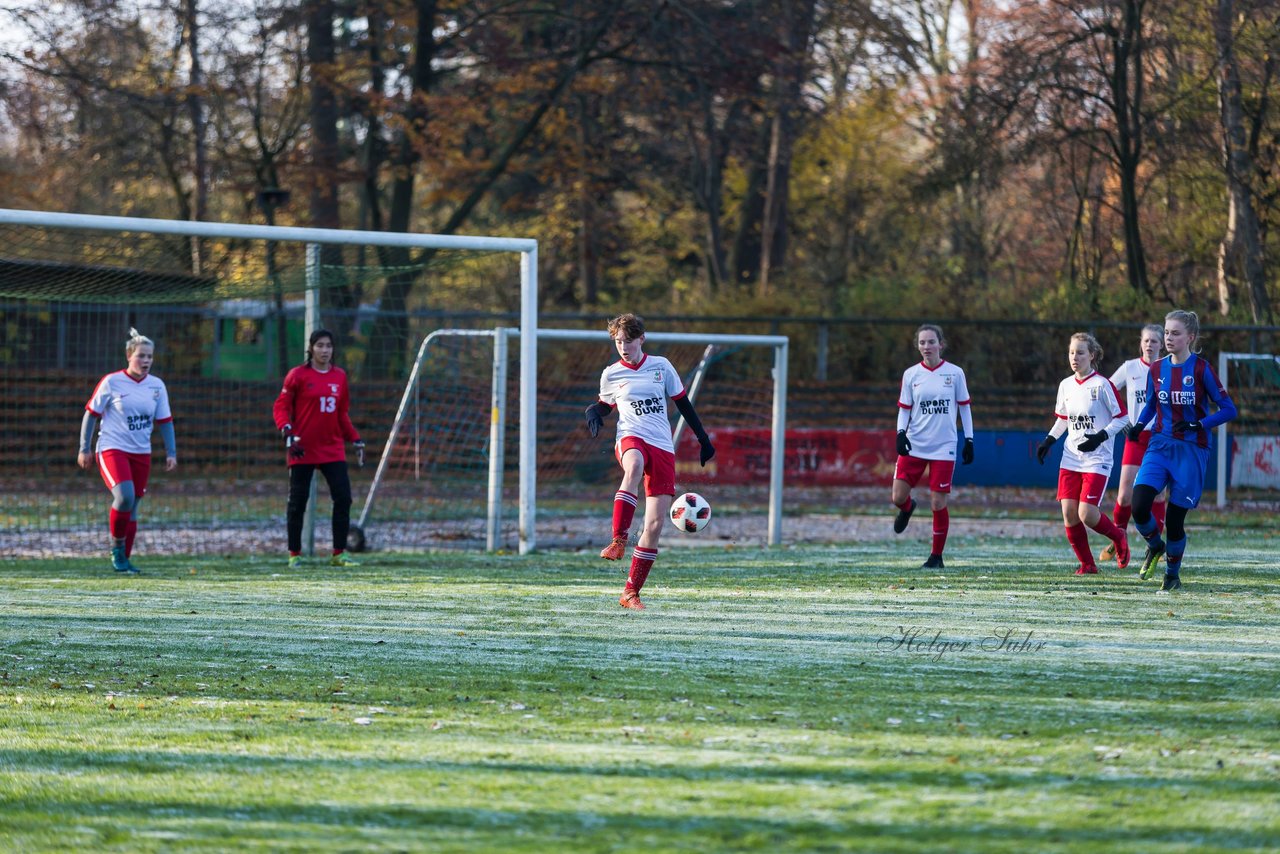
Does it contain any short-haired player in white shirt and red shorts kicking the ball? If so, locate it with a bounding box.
[586,314,716,611]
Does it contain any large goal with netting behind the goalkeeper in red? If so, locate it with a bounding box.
[0,210,536,557]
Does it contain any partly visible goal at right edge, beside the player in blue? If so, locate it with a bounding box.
[1217,353,1280,507]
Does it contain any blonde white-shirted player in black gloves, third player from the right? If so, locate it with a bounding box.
[1036,332,1129,575]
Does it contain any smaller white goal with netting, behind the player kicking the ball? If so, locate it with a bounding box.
[357,328,788,553]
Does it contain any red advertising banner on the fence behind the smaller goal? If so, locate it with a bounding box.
[676,428,897,487]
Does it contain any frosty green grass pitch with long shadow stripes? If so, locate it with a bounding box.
[0,537,1280,851]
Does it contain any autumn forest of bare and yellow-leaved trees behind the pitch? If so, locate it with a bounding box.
[0,0,1280,324]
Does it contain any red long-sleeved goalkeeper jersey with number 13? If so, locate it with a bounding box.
[273,365,360,466]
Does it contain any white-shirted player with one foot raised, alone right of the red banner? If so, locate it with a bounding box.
[891,323,973,568]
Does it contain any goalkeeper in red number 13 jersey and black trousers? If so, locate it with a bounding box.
[271,329,365,568]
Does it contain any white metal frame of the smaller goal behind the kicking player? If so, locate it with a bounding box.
[357,326,790,554]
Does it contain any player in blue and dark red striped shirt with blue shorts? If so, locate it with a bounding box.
[1129,310,1236,592]
